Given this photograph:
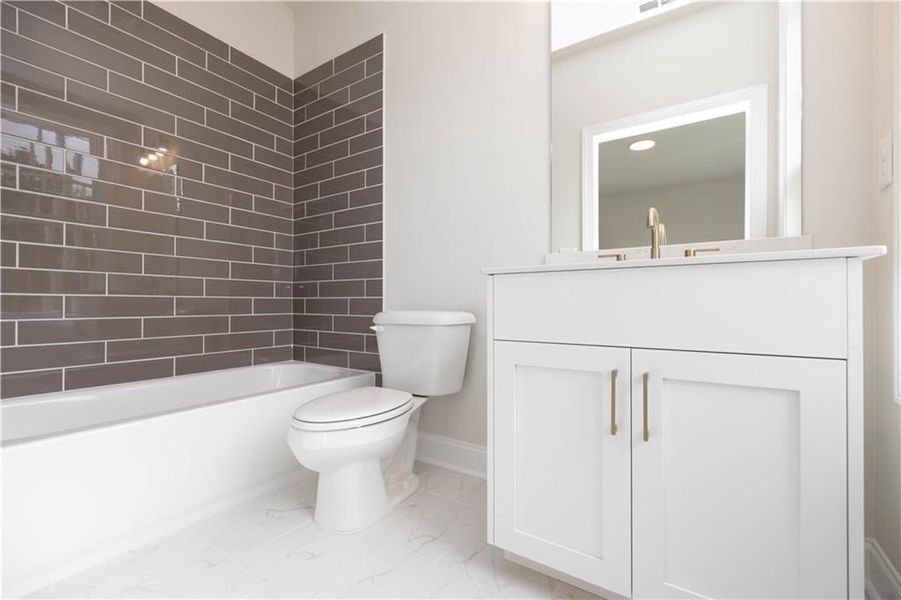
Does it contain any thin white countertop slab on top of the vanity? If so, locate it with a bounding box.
[482,246,886,275]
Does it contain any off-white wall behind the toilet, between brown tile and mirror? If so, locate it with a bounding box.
[296,2,550,445]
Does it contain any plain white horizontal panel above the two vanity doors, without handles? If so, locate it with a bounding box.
[494,258,848,358]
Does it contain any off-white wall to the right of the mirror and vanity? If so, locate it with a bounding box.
[803,3,901,568]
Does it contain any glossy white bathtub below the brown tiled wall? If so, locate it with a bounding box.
[2,362,374,597]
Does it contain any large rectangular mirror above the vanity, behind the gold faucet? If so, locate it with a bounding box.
[551,0,801,252]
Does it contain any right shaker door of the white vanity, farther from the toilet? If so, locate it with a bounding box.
[632,350,848,598]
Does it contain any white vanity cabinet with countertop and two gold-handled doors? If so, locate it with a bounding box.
[486,248,884,598]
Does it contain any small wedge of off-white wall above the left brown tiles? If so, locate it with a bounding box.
[157,0,295,79]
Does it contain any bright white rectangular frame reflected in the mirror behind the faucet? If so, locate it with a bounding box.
[582,84,767,250]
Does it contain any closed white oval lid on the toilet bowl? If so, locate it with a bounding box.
[293,387,413,429]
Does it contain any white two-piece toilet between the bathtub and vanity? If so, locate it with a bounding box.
[288,310,475,531]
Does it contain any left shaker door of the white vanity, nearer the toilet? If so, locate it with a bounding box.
[493,342,631,596]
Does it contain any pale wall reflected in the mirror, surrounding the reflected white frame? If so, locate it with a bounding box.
[551,2,776,251]
